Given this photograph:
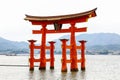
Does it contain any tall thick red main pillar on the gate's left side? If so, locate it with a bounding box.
[39,24,47,70]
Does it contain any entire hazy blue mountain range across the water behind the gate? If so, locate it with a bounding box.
[0,33,120,54]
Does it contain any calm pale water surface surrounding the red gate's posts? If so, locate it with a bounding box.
[0,55,120,80]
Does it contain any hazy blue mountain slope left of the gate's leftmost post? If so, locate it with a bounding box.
[0,37,28,53]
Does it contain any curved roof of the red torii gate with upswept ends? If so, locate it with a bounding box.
[25,8,97,24]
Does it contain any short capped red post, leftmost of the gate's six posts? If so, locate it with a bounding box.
[28,40,36,71]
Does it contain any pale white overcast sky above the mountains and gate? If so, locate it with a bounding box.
[0,0,120,41]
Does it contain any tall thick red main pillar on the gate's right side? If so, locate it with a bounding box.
[70,22,78,71]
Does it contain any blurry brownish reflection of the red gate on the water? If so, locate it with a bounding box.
[29,70,86,80]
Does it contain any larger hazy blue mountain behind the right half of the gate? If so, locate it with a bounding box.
[55,33,120,54]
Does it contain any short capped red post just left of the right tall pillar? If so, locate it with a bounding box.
[60,39,68,72]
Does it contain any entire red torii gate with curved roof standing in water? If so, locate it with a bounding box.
[25,8,97,72]
